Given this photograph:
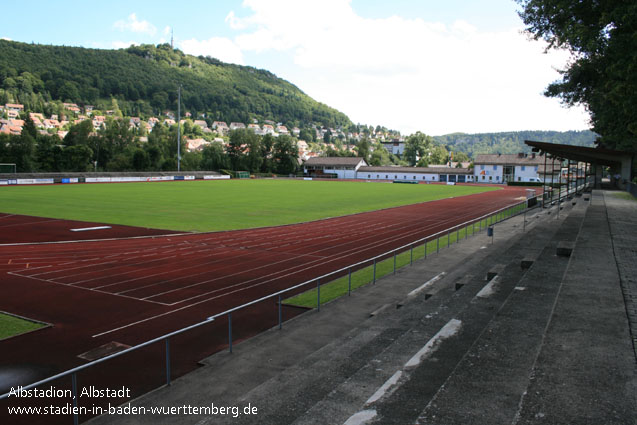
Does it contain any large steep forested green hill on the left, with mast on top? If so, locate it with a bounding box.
[0,40,350,127]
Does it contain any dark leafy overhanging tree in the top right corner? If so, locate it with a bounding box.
[517,0,637,152]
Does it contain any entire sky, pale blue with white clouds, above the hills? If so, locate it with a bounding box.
[0,0,589,135]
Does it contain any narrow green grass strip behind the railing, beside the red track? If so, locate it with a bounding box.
[283,205,525,308]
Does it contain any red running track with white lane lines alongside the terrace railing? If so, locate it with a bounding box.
[0,187,526,423]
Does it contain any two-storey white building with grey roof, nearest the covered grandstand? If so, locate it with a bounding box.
[473,153,544,183]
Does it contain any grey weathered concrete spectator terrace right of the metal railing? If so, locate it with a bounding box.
[91,192,637,424]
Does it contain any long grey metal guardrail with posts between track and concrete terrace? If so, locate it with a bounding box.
[0,185,585,424]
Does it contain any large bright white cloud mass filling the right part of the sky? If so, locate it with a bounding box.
[226,0,587,134]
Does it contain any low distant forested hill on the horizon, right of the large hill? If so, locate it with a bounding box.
[434,130,597,159]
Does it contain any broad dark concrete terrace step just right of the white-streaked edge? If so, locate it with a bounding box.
[412,207,581,424]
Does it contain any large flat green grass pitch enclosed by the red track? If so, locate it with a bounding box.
[0,180,498,231]
